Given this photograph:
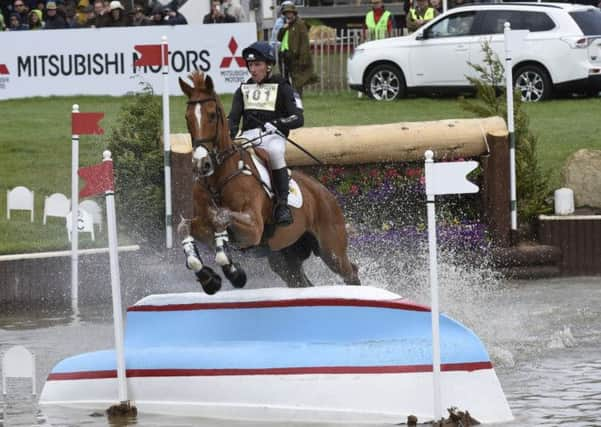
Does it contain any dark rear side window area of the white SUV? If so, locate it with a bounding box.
[478,10,555,34]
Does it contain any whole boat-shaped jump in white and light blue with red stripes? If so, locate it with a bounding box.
[40,286,512,423]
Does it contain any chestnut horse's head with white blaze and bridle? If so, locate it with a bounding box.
[179,71,231,176]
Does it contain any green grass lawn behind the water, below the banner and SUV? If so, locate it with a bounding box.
[0,92,601,253]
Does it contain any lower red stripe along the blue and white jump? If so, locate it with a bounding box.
[48,362,493,381]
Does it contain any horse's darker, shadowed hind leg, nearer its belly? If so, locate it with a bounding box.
[267,236,313,288]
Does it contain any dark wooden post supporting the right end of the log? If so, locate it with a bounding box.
[483,131,511,247]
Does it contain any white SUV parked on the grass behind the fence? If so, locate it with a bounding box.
[347,3,601,101]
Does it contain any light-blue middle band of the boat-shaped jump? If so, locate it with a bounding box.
[53,301,491,375]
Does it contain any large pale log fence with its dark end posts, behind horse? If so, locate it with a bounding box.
[171,117,511,246]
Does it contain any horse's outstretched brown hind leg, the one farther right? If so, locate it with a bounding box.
[319,221,361,285]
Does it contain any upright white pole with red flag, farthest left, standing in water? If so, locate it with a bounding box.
[71,104,79,314]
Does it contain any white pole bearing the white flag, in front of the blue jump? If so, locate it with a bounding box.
[425,150,442,421]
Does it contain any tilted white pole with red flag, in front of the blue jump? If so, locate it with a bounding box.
[102,150,128,403]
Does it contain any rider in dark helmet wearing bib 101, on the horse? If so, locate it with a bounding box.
[228,41,304,226]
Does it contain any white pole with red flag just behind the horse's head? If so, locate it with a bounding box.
[161,36,173,249]
